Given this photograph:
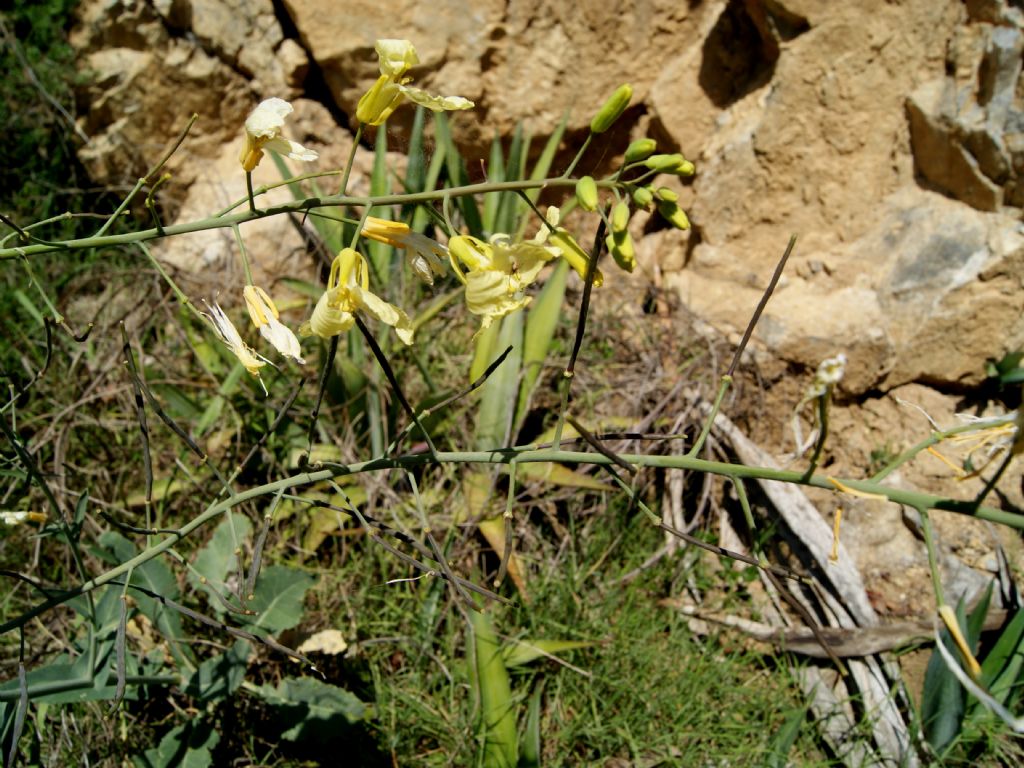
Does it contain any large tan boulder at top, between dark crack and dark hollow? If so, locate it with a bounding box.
[286,0,707,144]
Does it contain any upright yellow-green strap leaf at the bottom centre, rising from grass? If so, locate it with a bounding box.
[469,610,518,768]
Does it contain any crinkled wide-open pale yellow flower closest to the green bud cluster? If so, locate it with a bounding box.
[449,227,559,331]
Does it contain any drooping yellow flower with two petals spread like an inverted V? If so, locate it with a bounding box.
[299,248,413,344]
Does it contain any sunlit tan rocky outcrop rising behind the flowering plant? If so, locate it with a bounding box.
[74,0,1024,393]
